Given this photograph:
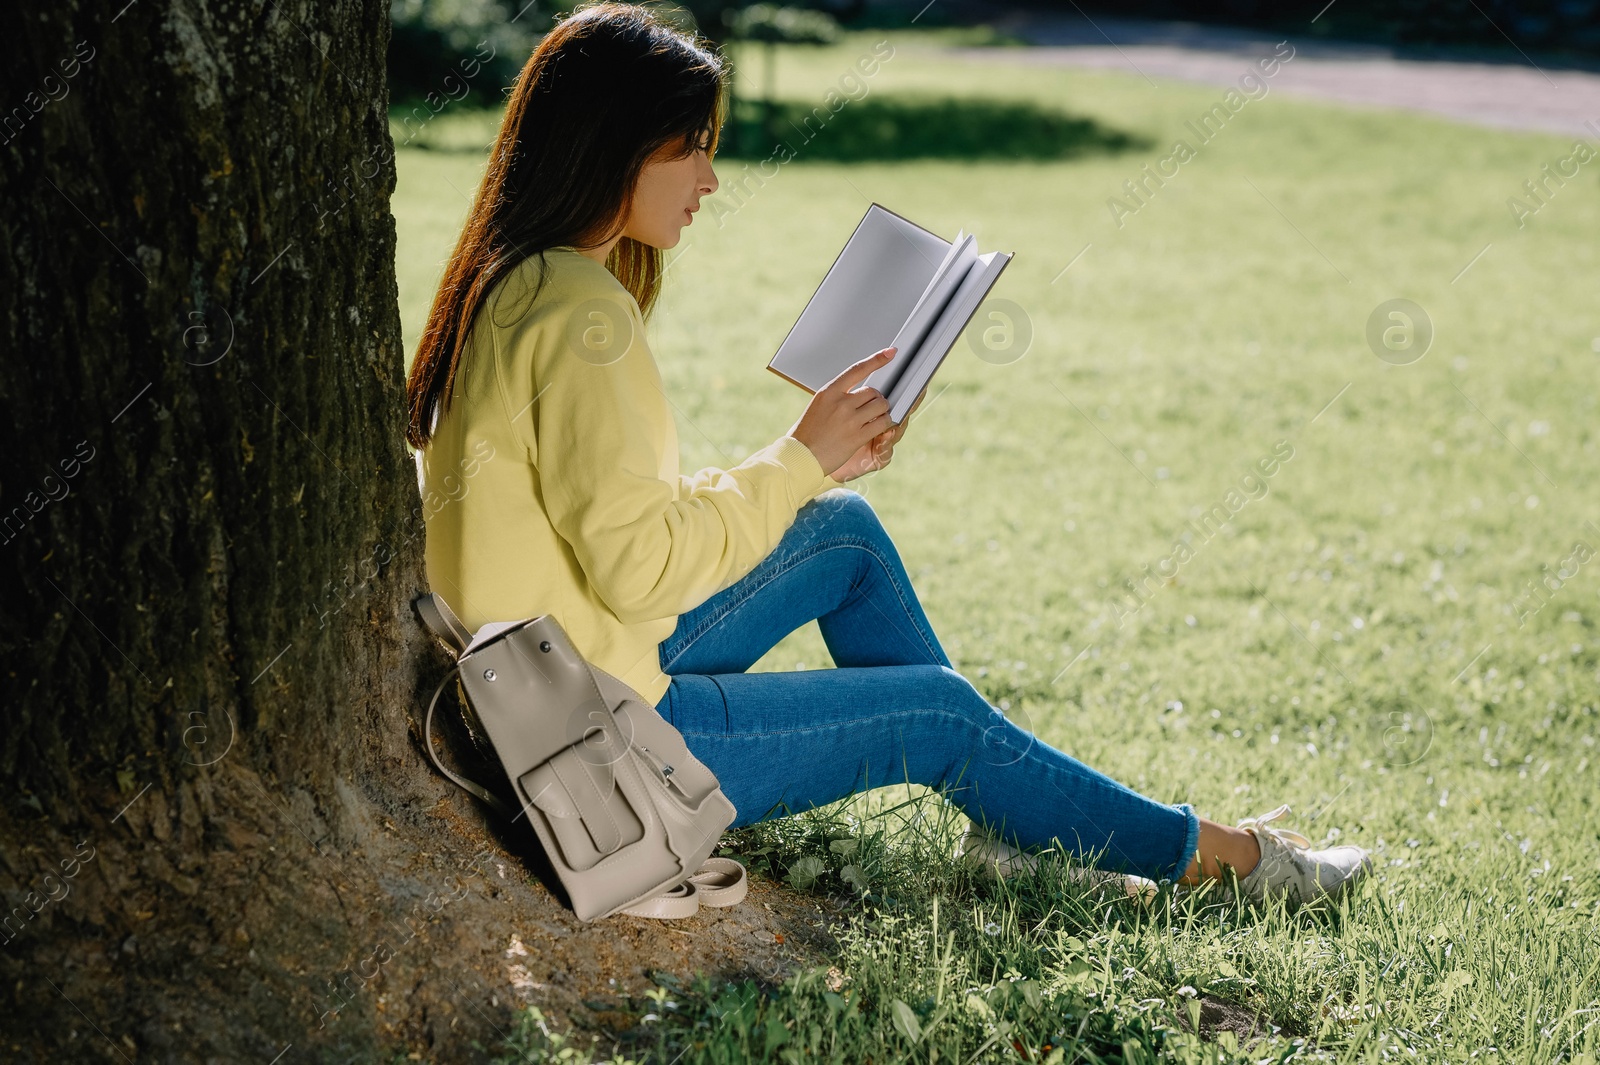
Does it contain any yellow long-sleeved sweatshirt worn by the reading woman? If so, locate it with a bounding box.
[416,248,840,705]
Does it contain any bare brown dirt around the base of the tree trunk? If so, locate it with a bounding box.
[0,761,842,1065]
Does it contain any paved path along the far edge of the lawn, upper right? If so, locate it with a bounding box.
[952,14,1600,137]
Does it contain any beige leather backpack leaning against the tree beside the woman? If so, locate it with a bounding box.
[406,595,749,921]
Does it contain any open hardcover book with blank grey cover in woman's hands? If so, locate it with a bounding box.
[766,203,1011,425]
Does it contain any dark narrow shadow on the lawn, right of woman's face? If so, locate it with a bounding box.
[718,93,1154,163]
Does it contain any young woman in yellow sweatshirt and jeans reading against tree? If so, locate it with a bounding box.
[406,3,1370,902]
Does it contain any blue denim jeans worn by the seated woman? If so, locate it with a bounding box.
[658,489,1200,880]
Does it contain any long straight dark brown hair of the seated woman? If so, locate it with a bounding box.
[406,3,726,448]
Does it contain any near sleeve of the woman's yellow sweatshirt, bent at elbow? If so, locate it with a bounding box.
[528,286,838,624]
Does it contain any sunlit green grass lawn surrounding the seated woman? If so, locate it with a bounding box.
[395,32,1600,1063]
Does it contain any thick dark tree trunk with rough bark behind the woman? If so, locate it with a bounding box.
[0,0,492,1062]
